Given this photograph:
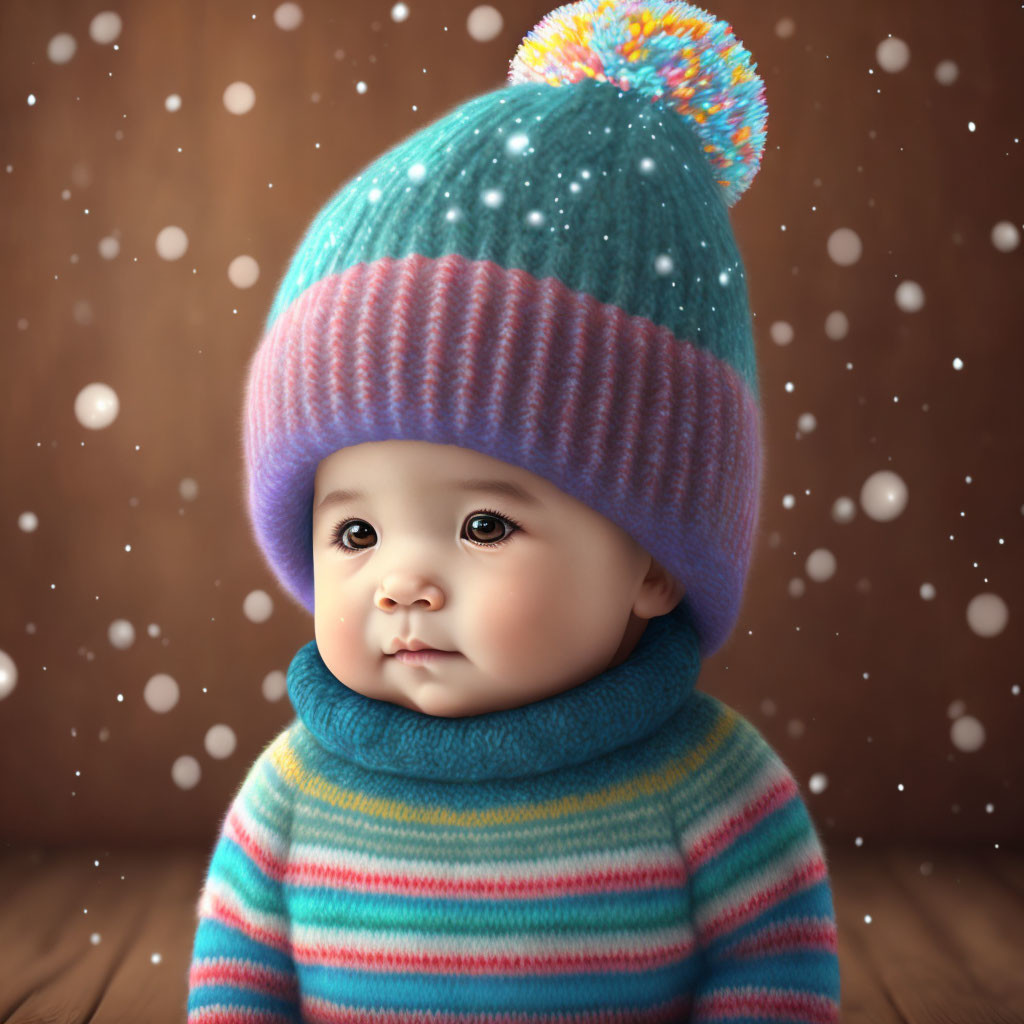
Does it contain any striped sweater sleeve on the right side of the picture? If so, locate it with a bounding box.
[677,698,840,1024]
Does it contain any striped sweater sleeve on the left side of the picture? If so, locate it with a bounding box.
[187,729,301,1024]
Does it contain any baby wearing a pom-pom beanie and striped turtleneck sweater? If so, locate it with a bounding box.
[187,0,840,1024]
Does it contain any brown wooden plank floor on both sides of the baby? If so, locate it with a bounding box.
[0,847,1024,1024]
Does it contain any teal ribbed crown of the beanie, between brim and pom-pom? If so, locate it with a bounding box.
[264,80,760,400]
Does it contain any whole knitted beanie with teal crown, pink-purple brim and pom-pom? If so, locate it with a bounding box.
[243,0,767,656]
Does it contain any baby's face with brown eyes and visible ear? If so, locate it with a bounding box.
[312,440,682,718]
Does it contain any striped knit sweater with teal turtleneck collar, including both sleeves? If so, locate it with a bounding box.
[187,605,840,1024]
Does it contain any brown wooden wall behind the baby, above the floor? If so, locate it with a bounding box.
[0,0,1024,846]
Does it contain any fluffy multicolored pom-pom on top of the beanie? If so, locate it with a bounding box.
[509,0,768,206]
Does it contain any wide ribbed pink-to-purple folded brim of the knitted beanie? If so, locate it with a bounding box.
[243,253,761,656]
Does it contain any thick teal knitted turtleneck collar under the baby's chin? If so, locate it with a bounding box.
[288,601,700,781]
